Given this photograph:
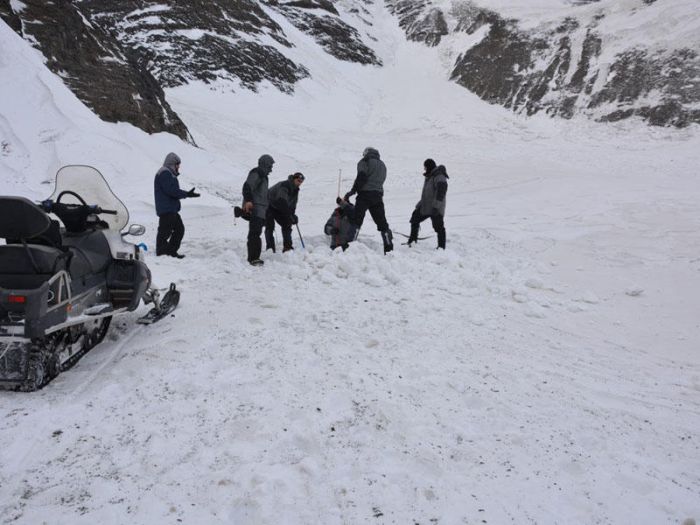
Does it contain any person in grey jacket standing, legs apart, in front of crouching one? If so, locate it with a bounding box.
[345,147,394,253]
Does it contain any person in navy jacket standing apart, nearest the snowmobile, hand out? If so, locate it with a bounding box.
[153,153,199,259]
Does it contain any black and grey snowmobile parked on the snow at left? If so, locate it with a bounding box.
[0,166,180,391]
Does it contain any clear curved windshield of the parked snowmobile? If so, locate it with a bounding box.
[49,166,129,231]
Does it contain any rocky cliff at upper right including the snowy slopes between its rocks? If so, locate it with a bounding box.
[386,0,700,127]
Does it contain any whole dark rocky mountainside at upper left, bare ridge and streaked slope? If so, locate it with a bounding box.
[0,0,381,140]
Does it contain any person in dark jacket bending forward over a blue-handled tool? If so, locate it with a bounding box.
[265,172,304,253]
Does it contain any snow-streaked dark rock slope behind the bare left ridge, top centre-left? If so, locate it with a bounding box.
[76,0,379,89]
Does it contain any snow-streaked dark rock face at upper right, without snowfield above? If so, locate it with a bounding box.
[386,0,700,127]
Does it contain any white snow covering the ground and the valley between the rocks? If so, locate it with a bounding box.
[0,0,700,524]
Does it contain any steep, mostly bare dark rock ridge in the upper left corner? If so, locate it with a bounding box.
[0,0,191,140]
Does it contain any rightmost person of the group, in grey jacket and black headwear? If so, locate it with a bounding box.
[408,159,449,250]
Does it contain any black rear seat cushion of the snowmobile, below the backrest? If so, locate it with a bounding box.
[0,244,68,290]
